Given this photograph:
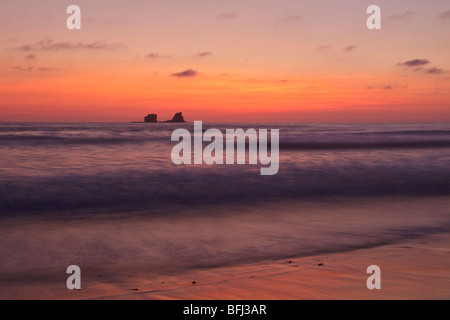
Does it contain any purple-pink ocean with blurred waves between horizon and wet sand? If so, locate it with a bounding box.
[0,123,450,282]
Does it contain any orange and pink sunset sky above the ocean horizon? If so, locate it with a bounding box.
[0,0,450,122]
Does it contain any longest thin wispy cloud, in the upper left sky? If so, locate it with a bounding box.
[18,38,124,51]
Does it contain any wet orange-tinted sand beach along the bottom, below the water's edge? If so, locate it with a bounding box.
[0,234,450,300]
